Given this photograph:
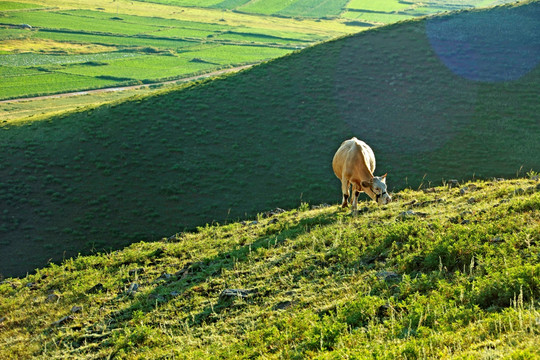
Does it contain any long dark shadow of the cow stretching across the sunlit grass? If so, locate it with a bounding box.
[108,212,339,328]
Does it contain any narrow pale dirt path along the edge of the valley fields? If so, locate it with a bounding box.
[0,64,255,104]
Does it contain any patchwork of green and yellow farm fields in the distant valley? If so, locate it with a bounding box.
[0,0,516,120]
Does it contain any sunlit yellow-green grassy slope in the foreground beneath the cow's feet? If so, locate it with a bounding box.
[0,176,540,359]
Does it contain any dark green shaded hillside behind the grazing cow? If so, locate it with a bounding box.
[0,1,540,275]
